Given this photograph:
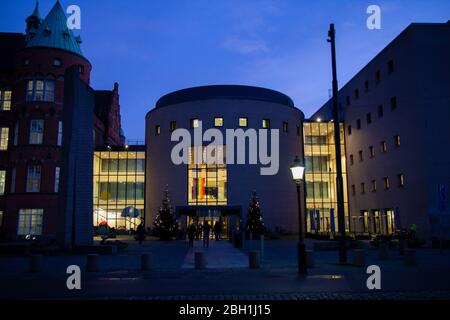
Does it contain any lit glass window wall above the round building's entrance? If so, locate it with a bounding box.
[188,146,227,205]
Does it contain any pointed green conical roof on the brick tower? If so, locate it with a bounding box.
[26,1,83,56]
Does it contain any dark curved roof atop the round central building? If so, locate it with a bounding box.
[156,85,294,108]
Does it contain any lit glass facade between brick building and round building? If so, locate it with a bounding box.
[94,146,145,234]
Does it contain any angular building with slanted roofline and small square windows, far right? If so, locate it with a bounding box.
[311,22,450,237]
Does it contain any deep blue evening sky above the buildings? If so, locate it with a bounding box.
[0,0,450,140]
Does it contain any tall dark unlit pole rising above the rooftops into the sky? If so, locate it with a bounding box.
[328,23,347,264]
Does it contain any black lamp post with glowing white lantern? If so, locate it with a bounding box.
[291,156,308,274]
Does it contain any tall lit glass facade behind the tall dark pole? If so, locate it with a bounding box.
[303,122,349,233]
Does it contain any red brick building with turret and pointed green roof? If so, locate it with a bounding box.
[0,2,124,239]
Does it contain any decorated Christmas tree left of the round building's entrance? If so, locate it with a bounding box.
[153,185,178,240]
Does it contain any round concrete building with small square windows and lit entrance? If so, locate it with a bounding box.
[145,85,304,235]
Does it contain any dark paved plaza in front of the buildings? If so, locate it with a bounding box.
[0,240,450,299]
